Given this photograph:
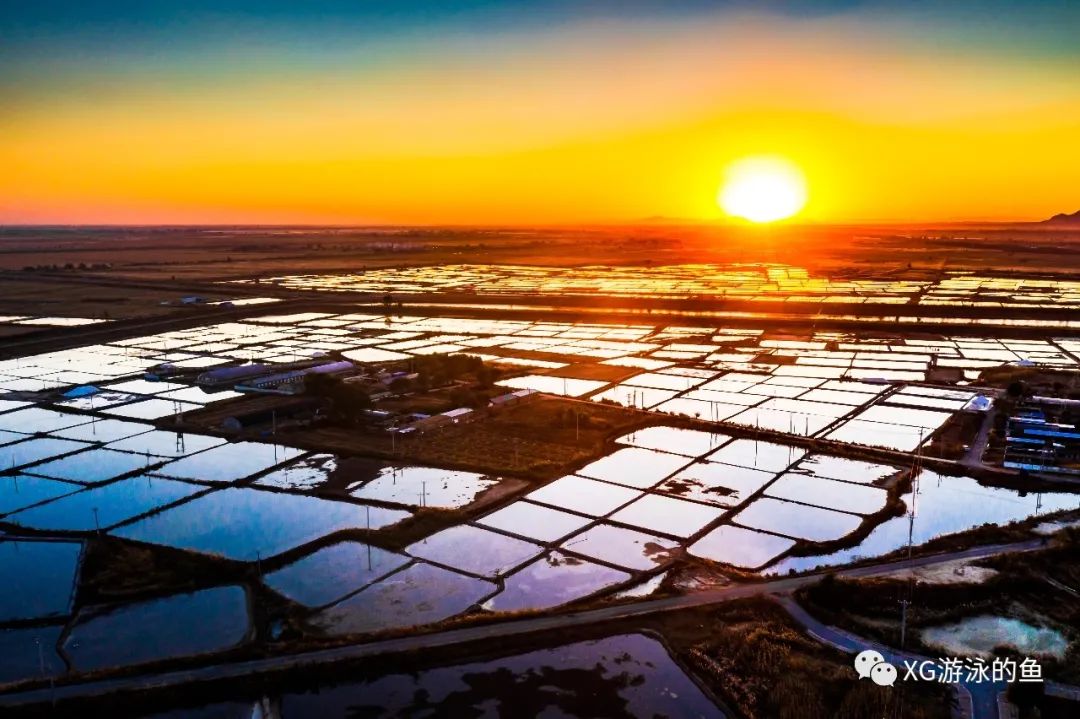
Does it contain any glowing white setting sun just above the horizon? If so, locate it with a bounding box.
[716,157,807,222]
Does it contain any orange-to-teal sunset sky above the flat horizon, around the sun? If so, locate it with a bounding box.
[0,0,1080,225]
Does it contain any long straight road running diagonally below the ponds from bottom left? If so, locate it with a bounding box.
[0,539,1042,703]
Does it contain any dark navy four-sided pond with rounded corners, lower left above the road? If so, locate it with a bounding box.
[64,586,251,671]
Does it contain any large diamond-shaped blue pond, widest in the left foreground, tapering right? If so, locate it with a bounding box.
[110,487,408,561]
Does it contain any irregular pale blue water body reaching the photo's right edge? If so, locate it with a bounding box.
[766,472,1080,574]
